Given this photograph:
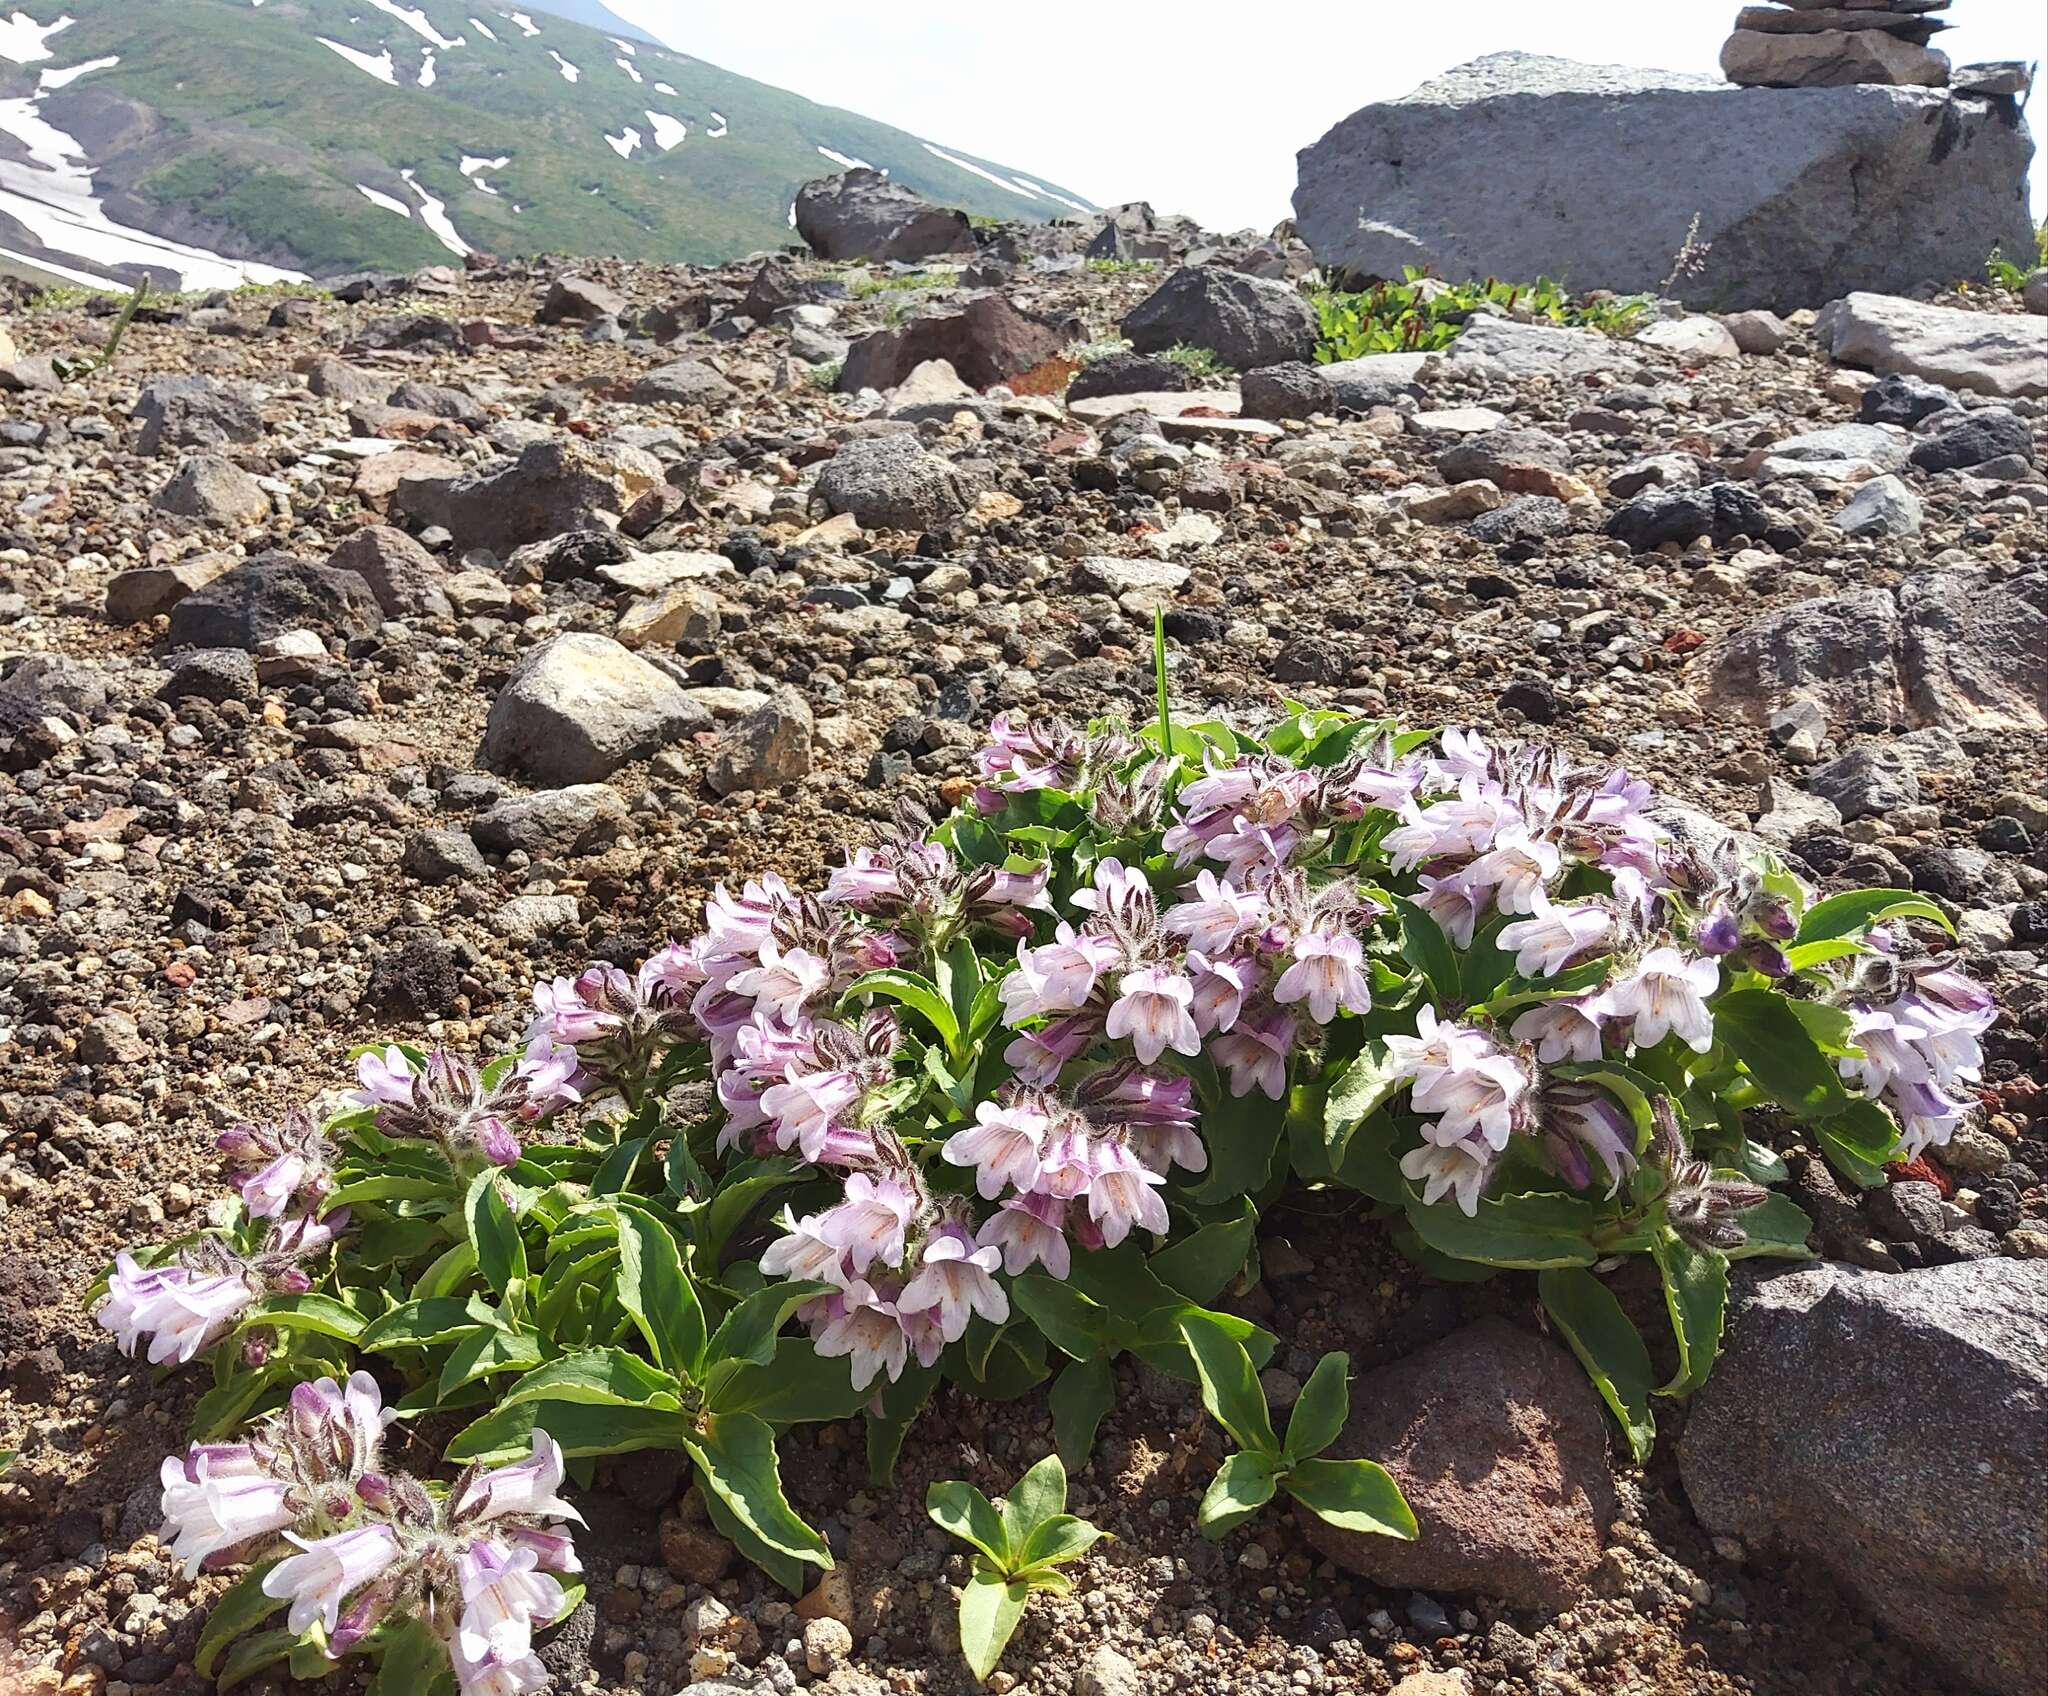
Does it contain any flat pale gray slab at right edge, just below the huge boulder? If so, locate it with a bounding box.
[1812,292,2048,399]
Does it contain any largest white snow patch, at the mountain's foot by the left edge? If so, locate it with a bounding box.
[0,89,305,289]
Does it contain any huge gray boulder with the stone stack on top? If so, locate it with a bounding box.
[1294,53,2034,309]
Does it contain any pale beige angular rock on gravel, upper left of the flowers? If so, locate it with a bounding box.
[479,631,711,787]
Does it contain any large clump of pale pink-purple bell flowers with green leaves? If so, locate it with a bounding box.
[100,626,1993,1692]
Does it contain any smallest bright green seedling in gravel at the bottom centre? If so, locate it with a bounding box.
[924,1454,1108,1684]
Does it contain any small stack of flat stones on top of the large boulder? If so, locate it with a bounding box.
[1720,0,1950,88]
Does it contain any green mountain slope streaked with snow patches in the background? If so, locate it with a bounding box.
[0,0,1085,287]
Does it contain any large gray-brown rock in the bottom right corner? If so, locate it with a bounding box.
[1677,1260,2048,1696]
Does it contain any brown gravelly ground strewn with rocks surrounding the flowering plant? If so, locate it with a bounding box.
[0,244,2048,1696]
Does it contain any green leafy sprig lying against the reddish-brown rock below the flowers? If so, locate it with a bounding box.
[1180,1313,1415,1542]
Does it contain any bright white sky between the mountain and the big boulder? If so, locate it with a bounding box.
[606,0,2048,229]
